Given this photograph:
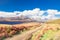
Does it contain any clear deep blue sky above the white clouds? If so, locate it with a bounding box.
[0,0,60,12]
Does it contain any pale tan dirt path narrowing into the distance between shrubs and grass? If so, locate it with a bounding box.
[5,27,43,40]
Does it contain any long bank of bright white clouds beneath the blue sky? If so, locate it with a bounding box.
[0,8,60,21]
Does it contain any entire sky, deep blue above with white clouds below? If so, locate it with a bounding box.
[0,0,60,21]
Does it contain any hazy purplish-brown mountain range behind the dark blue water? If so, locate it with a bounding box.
[0,16,33,22]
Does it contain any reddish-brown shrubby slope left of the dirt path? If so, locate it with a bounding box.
[0,22,41,40]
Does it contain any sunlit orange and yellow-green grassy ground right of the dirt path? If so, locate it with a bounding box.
[31,24,60,40]
